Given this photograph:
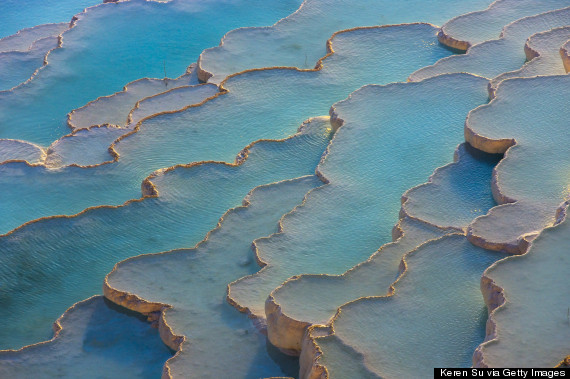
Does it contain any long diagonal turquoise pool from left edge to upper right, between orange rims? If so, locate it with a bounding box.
[0,24,450,232]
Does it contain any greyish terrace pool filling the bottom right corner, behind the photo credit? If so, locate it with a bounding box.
[474,214,570,367]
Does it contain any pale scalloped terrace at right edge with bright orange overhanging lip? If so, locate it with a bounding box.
[466,75,570,254]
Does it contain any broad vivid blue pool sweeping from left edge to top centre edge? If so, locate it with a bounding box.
[0,0,300,145]
